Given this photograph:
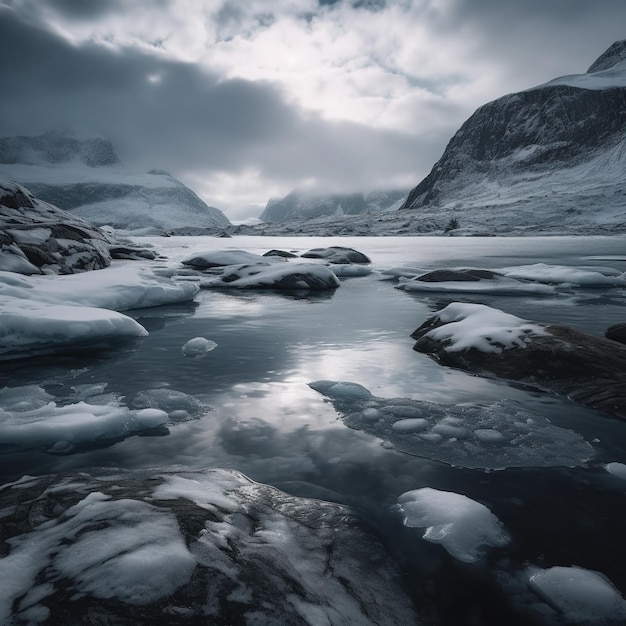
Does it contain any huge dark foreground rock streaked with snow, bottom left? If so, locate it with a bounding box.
[0,469,421,626]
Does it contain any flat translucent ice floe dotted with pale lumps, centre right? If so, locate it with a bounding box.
[309,380,594,469]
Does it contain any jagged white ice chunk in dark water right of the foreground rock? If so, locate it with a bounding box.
[398,487,509,563]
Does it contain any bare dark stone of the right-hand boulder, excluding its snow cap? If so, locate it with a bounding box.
[411,308,626,420]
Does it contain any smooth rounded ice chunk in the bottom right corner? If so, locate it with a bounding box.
[528,566,626,625]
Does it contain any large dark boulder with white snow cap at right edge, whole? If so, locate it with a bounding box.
[411,302,626,419]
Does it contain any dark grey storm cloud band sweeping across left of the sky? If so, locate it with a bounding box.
[0,10,430,188]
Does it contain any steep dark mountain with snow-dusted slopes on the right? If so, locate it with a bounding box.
[402,41,626,232]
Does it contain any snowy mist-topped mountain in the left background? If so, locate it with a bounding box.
[0,132,230,232]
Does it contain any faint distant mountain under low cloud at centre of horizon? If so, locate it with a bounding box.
[259,189,408,222]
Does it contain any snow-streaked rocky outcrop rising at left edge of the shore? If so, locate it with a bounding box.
[0,182,111,274]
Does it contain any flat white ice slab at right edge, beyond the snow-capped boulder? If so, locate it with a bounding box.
[499,263,626,287]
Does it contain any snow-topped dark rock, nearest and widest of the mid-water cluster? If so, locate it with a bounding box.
[200,262,340,289]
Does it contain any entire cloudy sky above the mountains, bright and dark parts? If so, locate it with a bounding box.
[0,0,626,220]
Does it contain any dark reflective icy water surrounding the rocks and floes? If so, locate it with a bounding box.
[0,236,626,624]
